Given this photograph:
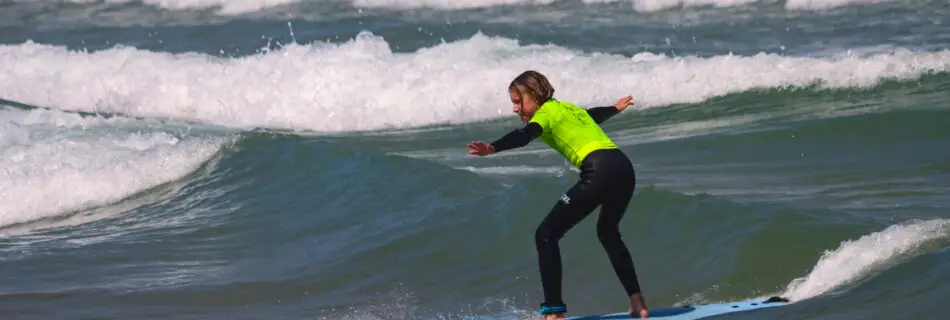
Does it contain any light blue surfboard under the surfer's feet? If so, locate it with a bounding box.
[566,297,789,320]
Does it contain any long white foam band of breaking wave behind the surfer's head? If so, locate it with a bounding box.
[0,33,950,132]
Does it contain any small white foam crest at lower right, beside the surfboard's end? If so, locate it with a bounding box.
[782,220,950,301]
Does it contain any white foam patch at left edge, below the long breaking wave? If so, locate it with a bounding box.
[0,110,231,227]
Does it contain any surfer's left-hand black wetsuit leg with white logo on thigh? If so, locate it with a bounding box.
[534,168,600,313]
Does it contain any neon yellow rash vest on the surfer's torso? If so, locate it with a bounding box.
[528,98,617,167]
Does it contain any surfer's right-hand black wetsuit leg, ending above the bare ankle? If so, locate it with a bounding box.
[597,153,640,296]
